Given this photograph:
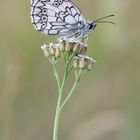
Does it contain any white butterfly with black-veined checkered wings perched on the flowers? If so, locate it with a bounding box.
[31,0,115,38]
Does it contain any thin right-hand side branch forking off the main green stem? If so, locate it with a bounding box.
[60,70,82,111]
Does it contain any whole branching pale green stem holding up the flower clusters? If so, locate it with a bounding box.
[52,55,82,140]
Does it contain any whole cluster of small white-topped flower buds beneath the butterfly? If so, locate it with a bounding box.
[41,38,96,70]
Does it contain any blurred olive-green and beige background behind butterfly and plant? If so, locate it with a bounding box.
[0,0,140,140]
